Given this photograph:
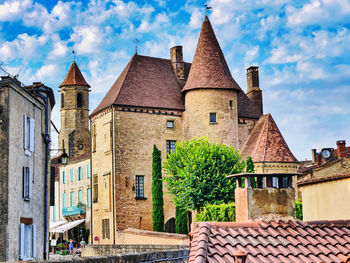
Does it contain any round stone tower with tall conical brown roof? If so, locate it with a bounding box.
[182,16,240,149]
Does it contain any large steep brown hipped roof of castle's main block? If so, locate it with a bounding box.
[91,54,190,115]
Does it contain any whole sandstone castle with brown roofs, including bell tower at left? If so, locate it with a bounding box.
[59,17,298,244]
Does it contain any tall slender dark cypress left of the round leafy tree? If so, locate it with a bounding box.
[152,145,164,232]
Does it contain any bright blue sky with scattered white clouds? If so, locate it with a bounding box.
[0,0,350,160]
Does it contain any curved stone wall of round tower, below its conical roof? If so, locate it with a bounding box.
[184,89,239,149]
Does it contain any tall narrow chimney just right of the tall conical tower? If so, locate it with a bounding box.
[247,66,264,115]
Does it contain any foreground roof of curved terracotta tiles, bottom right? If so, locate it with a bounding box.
[188,220,350,263]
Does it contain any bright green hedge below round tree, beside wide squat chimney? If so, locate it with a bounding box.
[196,202,236,222]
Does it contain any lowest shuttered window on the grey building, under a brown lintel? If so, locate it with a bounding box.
[19,224,36,260]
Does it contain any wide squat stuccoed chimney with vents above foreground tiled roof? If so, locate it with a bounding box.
[229,173,295,222]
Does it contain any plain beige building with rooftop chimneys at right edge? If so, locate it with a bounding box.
[297,140,350,221]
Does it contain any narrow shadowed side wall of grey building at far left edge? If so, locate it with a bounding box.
[0,83,9,261]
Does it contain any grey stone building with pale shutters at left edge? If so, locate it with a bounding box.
[0,77,55,261]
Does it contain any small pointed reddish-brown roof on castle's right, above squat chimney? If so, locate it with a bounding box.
[242,114,298,162]
